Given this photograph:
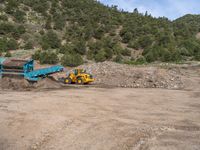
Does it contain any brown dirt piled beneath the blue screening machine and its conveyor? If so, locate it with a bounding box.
[0,77,62,91]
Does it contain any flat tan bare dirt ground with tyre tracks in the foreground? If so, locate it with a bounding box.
[0,65,200,150]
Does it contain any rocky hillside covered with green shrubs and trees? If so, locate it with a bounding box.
[0,0,200,66]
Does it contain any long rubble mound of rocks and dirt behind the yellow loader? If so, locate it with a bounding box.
[80,62,183,89]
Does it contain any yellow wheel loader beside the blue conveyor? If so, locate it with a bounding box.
[61,69,94,85]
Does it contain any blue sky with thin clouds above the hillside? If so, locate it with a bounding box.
[99,0,200,20]
